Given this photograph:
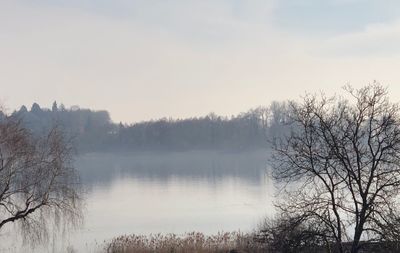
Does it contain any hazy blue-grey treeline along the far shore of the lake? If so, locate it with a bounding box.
[12,102,287,152]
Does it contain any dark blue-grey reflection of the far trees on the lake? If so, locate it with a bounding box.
[76,150,268,185]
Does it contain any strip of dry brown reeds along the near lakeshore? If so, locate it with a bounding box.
[105,232,265,253]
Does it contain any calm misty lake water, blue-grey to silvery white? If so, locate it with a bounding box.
[7,151,273,252]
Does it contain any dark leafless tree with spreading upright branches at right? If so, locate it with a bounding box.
[272,82,400,253]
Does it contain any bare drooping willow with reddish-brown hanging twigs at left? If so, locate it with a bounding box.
[0,113,81,243]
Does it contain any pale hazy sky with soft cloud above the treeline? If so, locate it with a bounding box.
[0,0,400,122]
